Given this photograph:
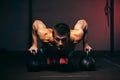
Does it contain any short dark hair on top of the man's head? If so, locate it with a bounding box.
[53,23,70,36]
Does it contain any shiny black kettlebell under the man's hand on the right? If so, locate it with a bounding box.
[82,51,95,70]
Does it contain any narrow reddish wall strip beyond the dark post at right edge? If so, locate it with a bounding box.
[114,0,120,51]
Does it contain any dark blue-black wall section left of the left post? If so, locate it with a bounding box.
[0,0,29,51]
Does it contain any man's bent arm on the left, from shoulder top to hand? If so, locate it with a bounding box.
[29,20,46,52]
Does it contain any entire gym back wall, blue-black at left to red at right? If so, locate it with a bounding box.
[0,0,120,51]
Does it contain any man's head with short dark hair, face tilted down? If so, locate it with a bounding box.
[53,23,70,50]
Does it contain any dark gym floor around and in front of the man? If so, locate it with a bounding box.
[0,51,120,80]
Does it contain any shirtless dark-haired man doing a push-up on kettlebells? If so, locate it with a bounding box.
[26,19,92,71]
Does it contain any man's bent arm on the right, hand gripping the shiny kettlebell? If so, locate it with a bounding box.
[74,19,92,52]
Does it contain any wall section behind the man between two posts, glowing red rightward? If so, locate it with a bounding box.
[33,0,110,50]
